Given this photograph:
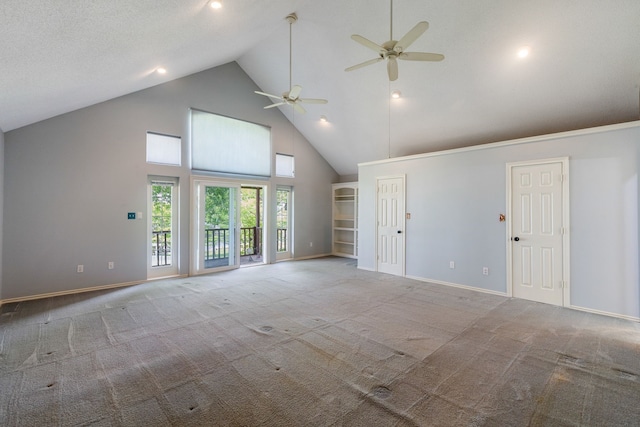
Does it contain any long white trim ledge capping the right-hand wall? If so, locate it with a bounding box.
[358,120,640,167]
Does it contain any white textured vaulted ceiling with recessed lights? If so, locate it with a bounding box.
[0,0,640,175]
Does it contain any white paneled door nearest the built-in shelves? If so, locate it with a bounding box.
[377,177,405,276]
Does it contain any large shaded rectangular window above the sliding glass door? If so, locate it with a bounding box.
[191,109,271,177]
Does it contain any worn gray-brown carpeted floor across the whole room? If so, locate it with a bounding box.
[0,258,640,426]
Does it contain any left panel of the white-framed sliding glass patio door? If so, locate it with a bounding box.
[192,180,240,274]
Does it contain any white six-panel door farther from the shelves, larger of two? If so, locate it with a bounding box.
[509,160,568,306]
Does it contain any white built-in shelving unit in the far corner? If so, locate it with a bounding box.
[332,182,358,258]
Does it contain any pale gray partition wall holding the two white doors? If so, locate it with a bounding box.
[358,122,640,318]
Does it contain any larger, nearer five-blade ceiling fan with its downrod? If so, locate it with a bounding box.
[345,0,444,81]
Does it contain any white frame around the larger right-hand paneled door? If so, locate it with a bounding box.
[505,157,571,307]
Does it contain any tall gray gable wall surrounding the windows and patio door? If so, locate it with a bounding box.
[2,62,338,299]
